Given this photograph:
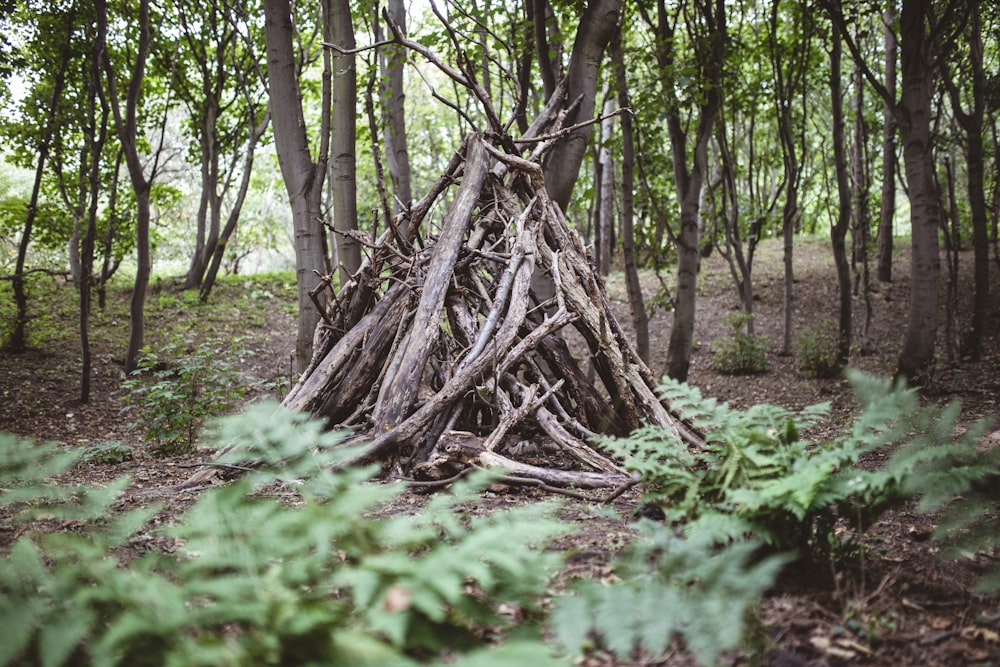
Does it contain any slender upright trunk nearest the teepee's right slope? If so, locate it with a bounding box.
[611,23,649,365]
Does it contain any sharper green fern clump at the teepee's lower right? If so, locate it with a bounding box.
[605,371,992,558]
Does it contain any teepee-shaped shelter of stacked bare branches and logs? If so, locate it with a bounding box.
[190,14,701,488]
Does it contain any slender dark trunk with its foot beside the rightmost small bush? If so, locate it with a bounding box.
[830,30,852,366]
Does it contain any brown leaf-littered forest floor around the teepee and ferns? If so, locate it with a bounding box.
[0,239,1000,667]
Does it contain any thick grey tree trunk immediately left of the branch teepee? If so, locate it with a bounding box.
[264,0,325,372]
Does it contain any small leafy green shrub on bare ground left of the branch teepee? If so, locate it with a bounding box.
[124,334,246,452]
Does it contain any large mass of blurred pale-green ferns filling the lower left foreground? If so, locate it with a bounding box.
[0,404,566,665]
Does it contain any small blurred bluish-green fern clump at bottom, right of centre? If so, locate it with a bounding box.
[552,520,787,665]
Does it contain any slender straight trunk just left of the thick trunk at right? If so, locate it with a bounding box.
[878,7,898,283]
